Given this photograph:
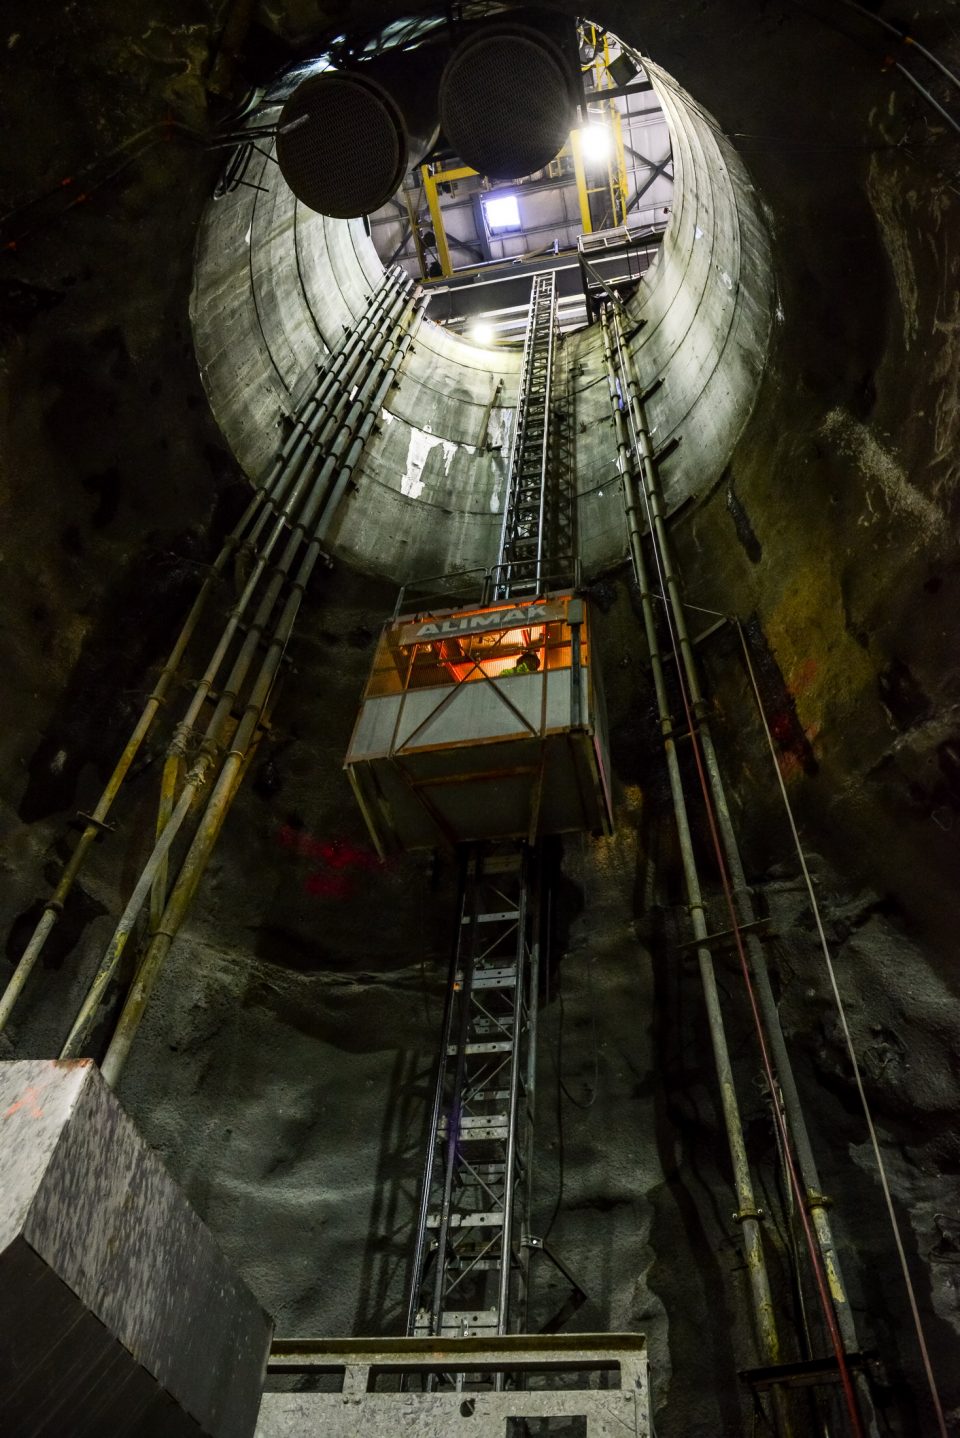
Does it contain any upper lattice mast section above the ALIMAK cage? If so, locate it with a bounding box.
[496,272,558,600]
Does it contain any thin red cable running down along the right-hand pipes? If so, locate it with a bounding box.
[614,314,868,1438]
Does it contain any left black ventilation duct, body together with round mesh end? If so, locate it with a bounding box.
[277,49,440,220]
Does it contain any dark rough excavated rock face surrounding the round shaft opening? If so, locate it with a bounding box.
[0,0,960,1438]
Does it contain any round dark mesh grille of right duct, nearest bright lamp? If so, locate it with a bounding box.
[440,27,573,180]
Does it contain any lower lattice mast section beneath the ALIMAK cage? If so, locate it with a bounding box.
[407,846,539,1337]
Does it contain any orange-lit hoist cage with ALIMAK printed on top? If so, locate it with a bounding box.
[345,591,611,854]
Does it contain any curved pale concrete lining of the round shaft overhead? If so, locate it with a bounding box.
[191,66,772,580]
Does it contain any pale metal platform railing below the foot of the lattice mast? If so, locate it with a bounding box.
[256,1333,651,1438]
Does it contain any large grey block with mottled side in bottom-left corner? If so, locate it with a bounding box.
[0,1060,272,1438]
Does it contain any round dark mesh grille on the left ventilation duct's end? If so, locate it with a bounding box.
[277,75,407,220]
